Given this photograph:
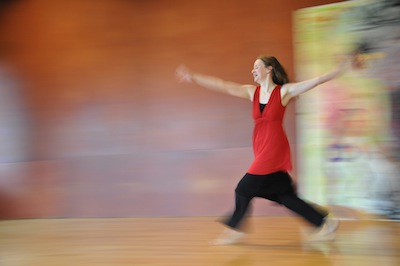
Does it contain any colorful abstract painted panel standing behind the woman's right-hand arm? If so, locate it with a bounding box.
[294,0,400,219]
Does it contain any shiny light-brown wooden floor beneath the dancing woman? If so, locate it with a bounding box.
[0,217,400,266]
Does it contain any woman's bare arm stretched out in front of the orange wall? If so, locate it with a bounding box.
[176,65,256,101]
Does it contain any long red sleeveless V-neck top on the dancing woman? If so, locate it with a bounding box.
[247,86,292,175]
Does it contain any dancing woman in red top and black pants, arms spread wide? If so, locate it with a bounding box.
[176,56,346,245]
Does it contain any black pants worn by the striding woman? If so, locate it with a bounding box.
[224,172,327,229]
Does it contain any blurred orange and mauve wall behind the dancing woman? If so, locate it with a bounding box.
[0,0,339,218]
